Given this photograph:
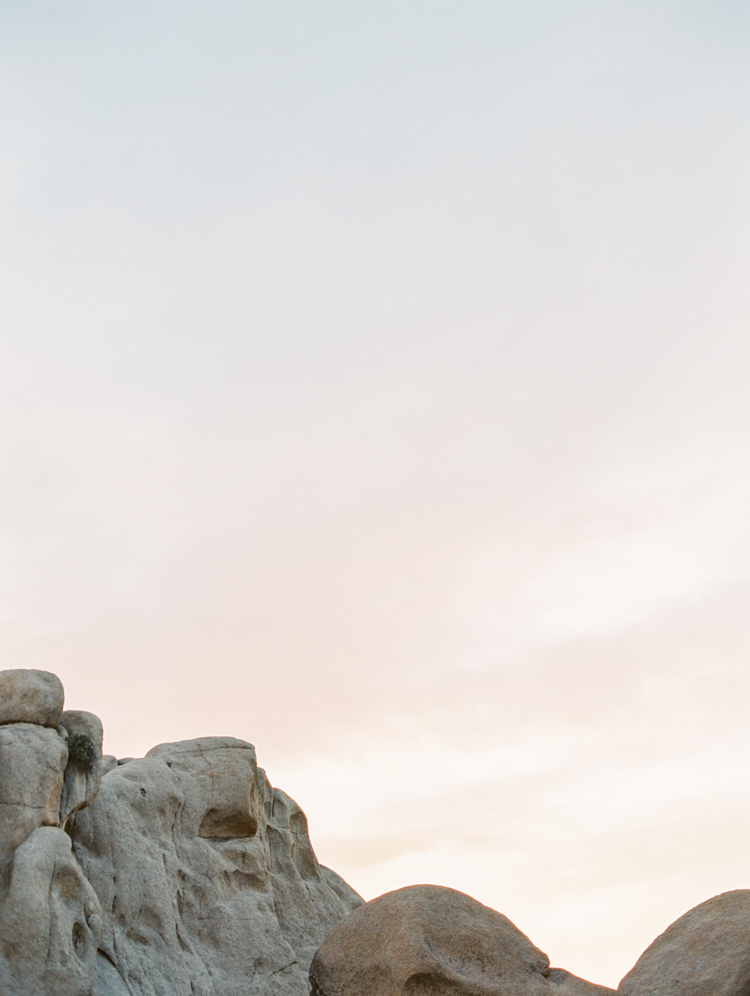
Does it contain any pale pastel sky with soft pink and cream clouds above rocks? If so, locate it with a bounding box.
[0,0,750,985]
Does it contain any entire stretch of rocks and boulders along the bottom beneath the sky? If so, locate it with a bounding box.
[0,670,750,996]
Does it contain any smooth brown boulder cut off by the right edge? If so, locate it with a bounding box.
[617,889,750,996]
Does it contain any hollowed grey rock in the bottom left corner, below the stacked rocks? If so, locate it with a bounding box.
[0,827,102,996]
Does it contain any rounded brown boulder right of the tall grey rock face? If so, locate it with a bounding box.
[310,885,613,996]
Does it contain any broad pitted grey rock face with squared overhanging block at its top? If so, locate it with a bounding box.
[71,737,361,996]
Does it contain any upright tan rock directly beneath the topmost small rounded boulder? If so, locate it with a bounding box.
[0,723,68,860]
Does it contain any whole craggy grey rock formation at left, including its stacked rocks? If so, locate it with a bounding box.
[0,670,362,996]
